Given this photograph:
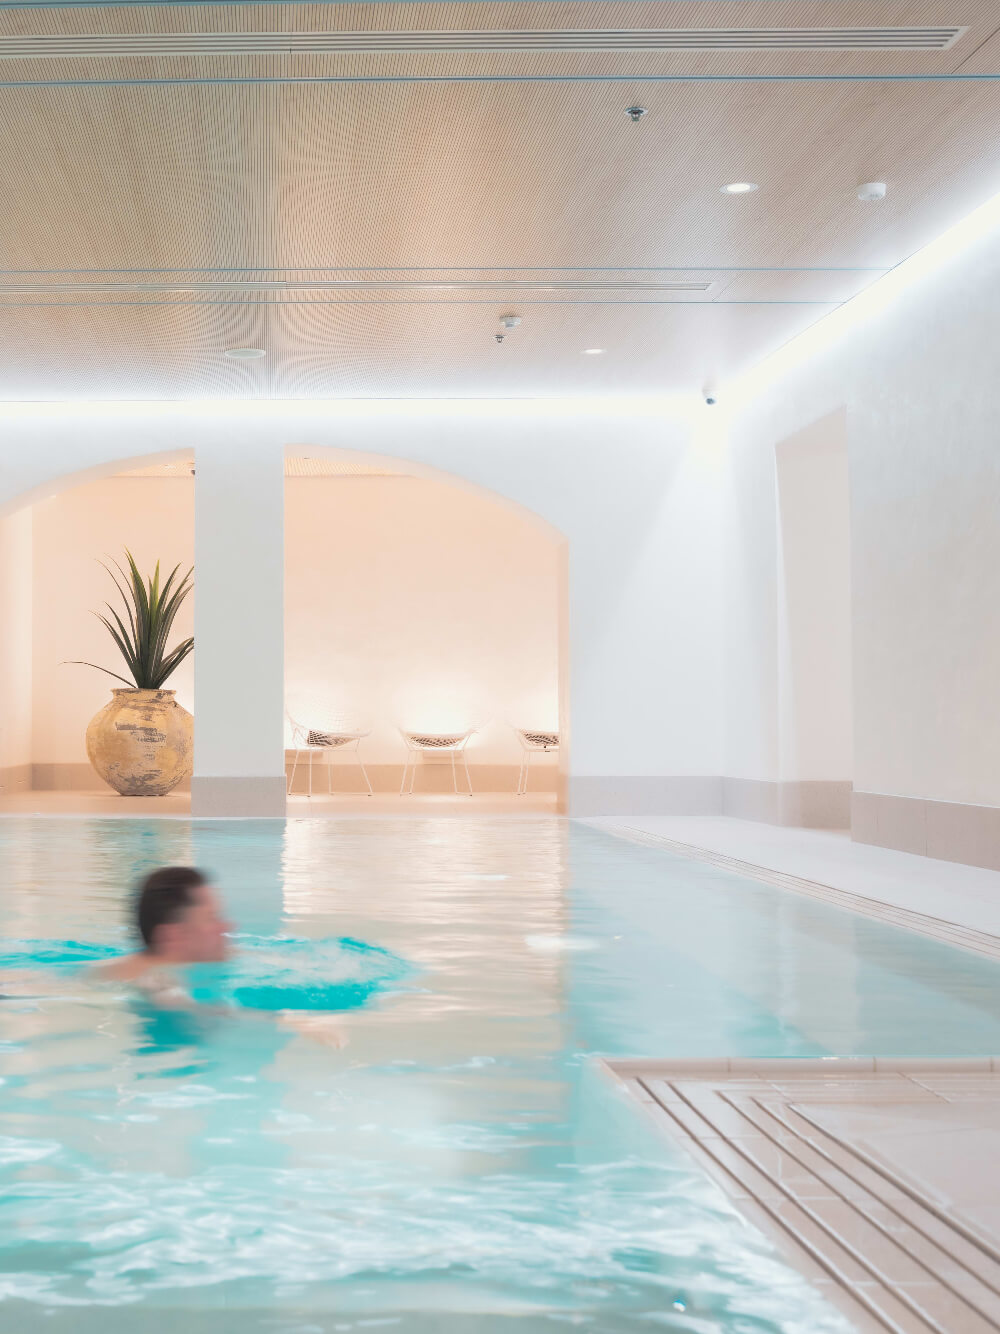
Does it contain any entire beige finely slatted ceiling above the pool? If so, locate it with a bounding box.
[0,0,1000,398]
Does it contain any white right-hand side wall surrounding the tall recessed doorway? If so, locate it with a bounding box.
[725,210,1000,806]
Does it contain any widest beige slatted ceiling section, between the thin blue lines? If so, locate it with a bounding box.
[0,84,1000,272]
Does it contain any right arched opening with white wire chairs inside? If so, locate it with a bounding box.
[285,444,568,814]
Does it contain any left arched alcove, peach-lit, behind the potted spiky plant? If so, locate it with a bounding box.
[0,451,195,814]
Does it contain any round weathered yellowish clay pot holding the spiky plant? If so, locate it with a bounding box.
[87,688,195,796]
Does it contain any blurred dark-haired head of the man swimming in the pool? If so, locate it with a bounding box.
[136,866,232,963]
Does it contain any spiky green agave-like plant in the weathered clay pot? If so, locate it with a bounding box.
[71,550,195,690]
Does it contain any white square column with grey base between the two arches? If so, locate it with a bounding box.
[191,435,285,816]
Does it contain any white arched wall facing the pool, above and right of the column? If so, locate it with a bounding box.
[0,400,723,808]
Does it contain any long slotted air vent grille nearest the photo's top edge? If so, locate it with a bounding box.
[0,28,965,60]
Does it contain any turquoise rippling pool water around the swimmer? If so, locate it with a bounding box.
[0,818,1000,1334]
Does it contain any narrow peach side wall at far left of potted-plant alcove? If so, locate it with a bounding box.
[0,510,32,791]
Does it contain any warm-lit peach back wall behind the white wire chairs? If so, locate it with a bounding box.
[285,476,560,764]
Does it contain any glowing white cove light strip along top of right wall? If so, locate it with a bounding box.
[725,182,1000,407]
